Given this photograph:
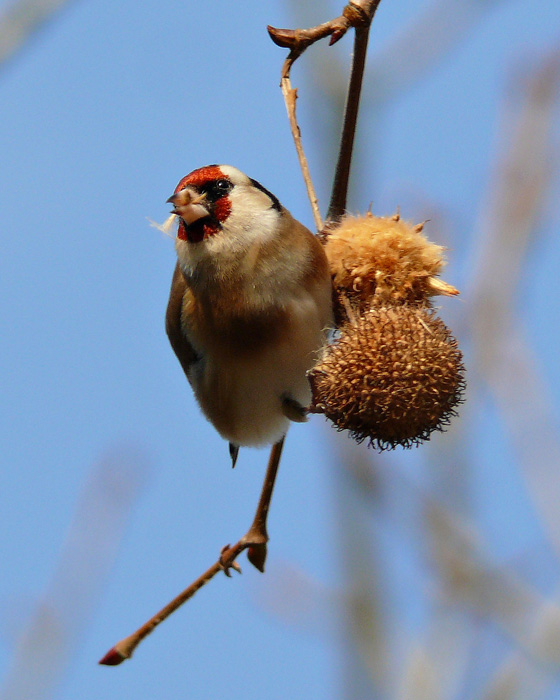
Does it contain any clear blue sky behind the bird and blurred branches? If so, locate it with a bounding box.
[0,0,560,700]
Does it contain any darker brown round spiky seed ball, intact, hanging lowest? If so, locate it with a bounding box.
[309,305,465,450]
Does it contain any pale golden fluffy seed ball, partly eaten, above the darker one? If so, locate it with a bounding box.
[325,213,459,313]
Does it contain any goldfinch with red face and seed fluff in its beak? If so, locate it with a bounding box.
[165,165,333,466]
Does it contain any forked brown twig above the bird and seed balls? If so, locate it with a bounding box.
[268,0,381,231]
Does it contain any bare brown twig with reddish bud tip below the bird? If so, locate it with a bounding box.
[99,438,284,666]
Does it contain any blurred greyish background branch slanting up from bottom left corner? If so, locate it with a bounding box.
[0,449,148,700]
